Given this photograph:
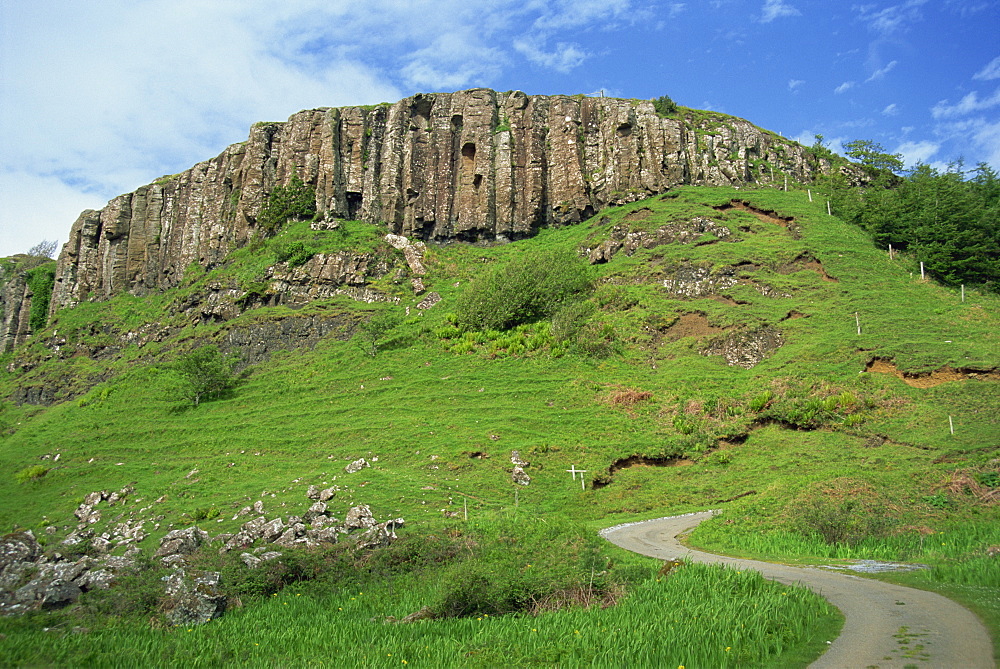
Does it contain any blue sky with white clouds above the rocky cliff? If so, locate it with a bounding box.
[0,0,1000,257]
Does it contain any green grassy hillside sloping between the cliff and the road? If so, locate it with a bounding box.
[0,183,1000,666]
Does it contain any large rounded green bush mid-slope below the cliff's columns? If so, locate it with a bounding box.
[455,250,591,330]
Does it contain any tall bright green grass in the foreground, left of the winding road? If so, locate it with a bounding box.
[0,565,839,667]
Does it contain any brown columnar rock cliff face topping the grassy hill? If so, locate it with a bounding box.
[52,89,817,310]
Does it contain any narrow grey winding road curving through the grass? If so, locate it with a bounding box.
[601,511,996,669]
